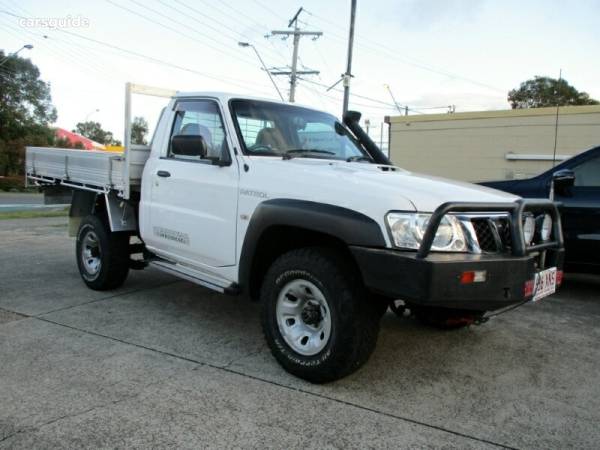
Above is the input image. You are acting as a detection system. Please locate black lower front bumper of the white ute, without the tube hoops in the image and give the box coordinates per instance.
[351,247,564,311]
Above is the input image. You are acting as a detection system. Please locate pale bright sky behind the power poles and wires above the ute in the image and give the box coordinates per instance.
[0,0,600,142]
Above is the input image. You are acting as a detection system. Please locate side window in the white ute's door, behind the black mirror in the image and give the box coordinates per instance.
[168,100,227,160]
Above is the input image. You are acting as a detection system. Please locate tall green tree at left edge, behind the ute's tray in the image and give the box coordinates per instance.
[0,51,56,176]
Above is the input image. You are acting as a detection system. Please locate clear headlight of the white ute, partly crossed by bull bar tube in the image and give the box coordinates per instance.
[386,212,467,252]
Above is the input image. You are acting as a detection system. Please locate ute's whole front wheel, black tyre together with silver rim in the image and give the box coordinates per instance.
[261,248,380,383]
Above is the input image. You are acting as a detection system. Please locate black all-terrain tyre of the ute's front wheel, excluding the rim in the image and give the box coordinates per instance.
[260,247,380,383]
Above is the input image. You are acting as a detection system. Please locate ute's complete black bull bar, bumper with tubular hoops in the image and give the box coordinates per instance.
[351,200,564,311]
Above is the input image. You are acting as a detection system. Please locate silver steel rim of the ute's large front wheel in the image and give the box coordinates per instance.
[276,280,331,356]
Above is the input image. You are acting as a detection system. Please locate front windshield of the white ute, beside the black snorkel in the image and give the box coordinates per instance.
[231,100,371,161]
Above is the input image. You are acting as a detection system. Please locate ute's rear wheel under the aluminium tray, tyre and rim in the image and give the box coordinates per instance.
[76,215,129,291]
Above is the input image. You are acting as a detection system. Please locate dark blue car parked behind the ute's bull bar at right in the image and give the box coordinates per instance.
[481,147,600,273]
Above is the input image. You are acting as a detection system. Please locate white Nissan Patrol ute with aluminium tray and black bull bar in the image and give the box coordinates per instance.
[26,83,564,383]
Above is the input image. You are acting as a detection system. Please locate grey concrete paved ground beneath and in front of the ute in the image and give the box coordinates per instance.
[0,218,600,449]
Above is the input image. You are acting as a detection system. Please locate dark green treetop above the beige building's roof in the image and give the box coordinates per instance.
[508,76,600,109]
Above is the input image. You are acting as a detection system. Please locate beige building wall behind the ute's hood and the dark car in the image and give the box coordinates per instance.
[387,105,600,182]
